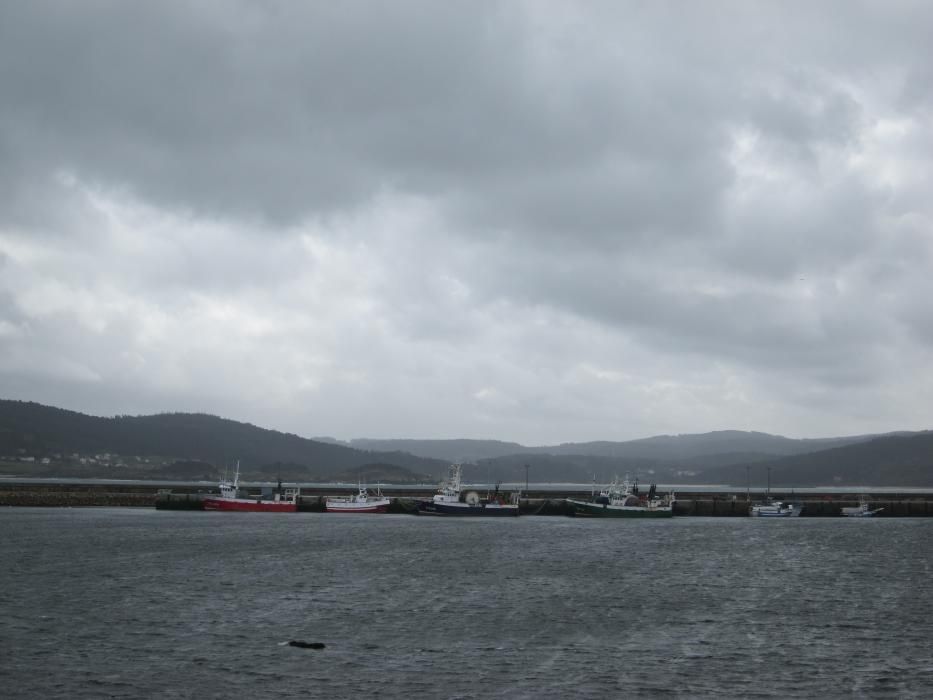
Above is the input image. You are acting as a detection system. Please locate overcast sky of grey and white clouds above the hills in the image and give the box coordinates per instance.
[0,0,933,444]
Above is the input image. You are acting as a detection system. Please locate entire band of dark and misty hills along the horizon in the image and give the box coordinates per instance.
[0,400,933,486]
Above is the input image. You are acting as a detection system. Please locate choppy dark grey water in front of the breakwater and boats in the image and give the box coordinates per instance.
[0,509,933,698]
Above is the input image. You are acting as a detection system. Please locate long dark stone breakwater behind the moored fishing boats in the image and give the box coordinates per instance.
[0,478,933,517]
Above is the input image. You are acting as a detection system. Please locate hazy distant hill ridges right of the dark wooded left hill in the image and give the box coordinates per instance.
[349,430,933,486]
